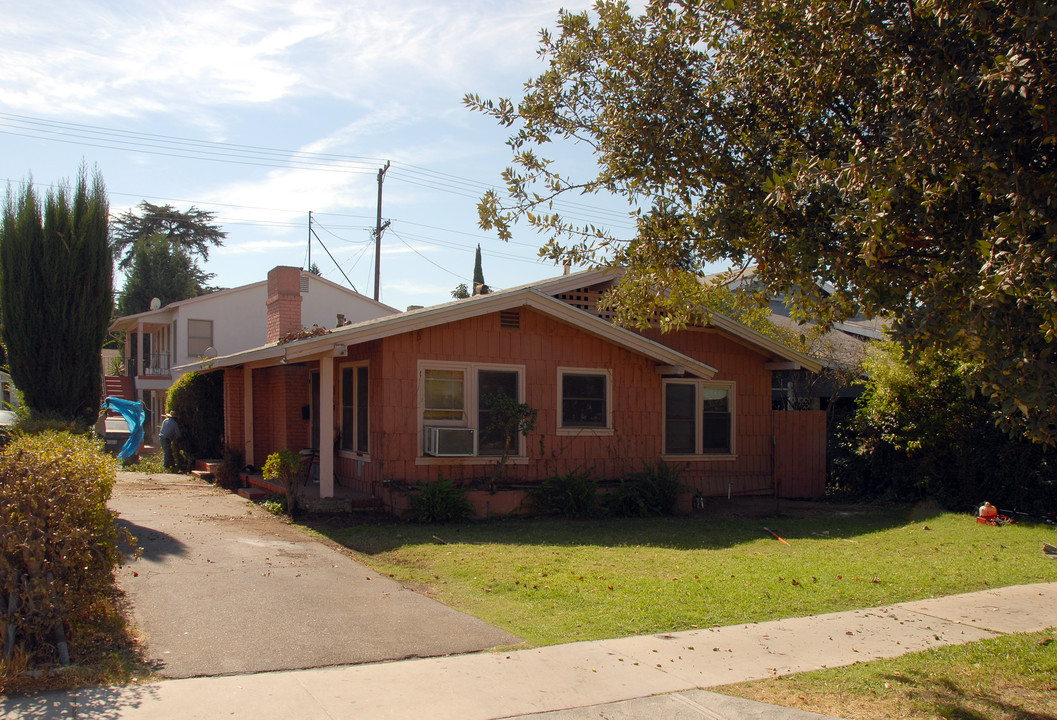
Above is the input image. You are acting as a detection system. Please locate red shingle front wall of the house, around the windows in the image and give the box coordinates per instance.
[335,309,773,495]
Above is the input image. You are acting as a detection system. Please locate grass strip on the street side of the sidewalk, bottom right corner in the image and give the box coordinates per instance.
[709,629,1057,720]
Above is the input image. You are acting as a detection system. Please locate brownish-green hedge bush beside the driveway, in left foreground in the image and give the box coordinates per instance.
[0,432,135,666]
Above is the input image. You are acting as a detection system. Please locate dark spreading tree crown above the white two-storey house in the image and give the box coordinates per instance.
[112,200,227,271]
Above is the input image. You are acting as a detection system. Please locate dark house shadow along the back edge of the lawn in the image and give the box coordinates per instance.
[301,498,944,555]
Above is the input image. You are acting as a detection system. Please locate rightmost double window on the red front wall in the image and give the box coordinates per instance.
[664,380,734,456]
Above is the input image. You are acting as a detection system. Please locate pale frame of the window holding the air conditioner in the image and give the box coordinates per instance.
[415,359,529,465]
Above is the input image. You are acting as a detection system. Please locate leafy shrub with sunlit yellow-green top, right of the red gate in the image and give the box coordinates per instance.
[831,341,1057,513]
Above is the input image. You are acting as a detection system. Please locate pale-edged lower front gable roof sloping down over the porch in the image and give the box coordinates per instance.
[175,285,716,380]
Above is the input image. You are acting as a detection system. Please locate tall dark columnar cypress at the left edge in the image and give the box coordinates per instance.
[0,168,113,422]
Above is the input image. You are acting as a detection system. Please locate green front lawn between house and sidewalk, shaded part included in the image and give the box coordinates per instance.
[314,505,1057,645]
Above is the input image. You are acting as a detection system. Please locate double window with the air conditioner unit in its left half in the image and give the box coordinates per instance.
[419,362,524,457]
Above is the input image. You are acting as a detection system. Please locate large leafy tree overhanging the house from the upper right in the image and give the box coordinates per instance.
[466,0,1057,443]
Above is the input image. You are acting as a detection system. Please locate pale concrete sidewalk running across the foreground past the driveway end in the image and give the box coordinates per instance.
[0,583,1057,720]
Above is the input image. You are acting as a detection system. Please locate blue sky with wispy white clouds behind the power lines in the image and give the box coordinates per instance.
[0,0,633,309]
